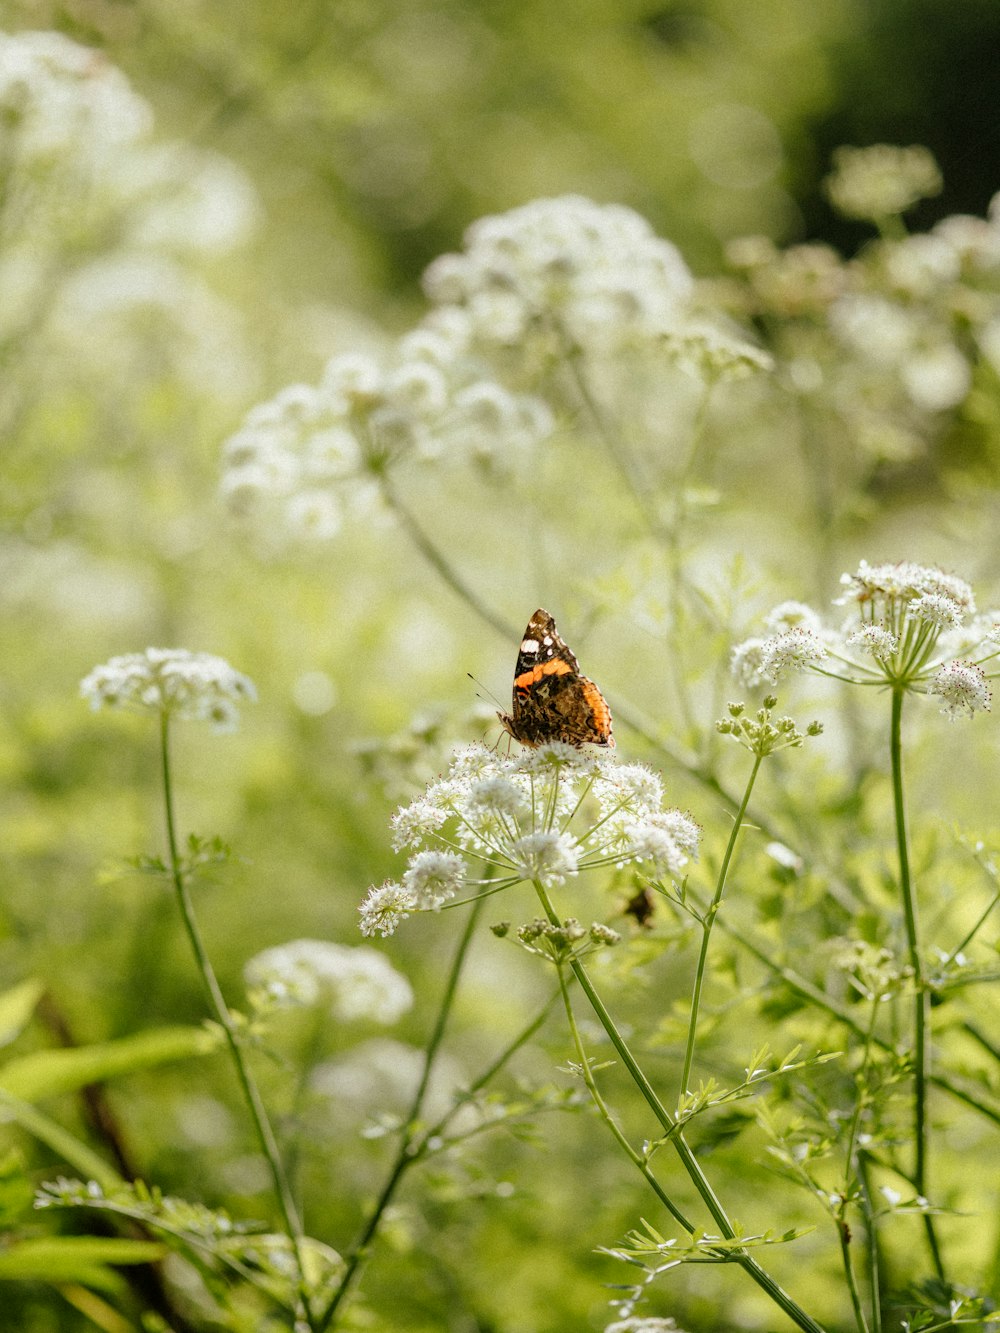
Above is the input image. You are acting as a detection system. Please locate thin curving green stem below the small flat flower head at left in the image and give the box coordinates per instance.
[160,709,317,1333]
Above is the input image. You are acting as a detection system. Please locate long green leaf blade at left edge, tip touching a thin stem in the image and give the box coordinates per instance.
[0,1028,216,1101]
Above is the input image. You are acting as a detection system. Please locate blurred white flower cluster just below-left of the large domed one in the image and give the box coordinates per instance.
[221,327,553,540]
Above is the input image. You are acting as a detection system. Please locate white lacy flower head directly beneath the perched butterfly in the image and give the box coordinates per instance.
[360,742,701,936]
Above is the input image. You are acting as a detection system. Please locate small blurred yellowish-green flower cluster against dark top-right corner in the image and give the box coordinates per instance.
[824,144,943,223]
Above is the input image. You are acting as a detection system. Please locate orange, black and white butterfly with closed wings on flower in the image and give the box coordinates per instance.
[496,608,615,746]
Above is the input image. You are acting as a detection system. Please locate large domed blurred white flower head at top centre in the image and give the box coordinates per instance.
[424,195,693,367]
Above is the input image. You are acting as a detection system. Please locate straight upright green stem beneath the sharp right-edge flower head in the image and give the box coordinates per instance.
[889,684,944,1278]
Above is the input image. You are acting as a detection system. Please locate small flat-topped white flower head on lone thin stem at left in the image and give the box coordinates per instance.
[80,648,256,732]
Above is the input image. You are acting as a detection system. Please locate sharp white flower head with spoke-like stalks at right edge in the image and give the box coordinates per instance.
[732,560,1000,717]
